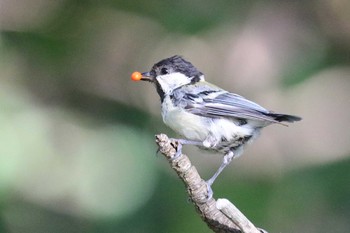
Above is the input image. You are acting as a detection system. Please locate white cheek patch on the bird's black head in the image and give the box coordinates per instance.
[156,73,191,94]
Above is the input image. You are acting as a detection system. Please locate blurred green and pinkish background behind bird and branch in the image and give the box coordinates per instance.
[0,0,350,233]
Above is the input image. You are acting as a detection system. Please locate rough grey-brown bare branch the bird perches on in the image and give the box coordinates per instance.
[156,134,266,233]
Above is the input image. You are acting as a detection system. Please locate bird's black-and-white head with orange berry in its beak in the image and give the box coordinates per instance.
[131,55,204,99]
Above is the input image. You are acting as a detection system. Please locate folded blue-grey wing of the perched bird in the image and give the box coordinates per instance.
[181,84,278,123]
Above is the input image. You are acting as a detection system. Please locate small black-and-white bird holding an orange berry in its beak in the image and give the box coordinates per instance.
[131,55,301,195]
